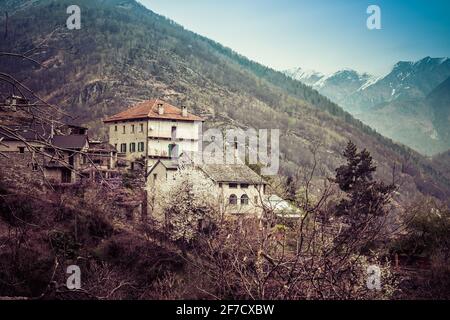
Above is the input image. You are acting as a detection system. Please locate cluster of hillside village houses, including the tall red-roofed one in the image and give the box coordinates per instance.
[0,95,300,224]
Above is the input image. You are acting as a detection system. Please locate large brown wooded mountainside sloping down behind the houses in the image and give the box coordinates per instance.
[0,0,450,205]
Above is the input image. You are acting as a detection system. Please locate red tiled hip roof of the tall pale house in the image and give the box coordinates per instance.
[103,99,204,122]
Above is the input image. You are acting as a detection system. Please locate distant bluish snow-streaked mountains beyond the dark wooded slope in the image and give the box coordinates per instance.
[286,57,450,155]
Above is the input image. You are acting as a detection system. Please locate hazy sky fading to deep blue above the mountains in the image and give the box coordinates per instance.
[140,0,450,75]
